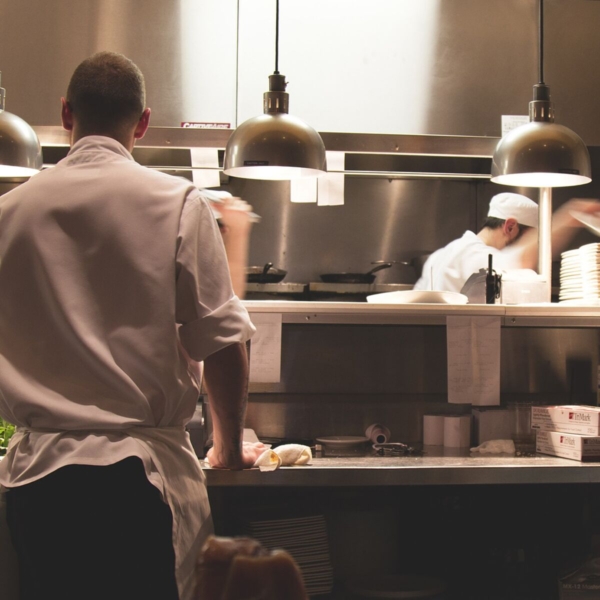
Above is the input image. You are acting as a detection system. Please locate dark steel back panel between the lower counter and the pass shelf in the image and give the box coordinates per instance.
[247,325,599,443]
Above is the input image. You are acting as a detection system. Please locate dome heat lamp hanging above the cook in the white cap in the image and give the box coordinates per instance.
[492,0,592,188]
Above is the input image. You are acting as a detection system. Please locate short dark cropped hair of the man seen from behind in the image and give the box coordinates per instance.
[66,52,146,135]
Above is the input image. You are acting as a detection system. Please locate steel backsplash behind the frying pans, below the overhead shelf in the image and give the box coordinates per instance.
[228,176,476,283]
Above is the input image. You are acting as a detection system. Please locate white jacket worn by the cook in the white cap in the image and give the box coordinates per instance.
[413,231,521,292]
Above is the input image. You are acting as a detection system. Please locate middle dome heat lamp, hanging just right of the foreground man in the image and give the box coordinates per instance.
[223,0,327,180]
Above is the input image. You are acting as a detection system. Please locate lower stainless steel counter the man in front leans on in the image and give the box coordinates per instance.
[204,455,600,487]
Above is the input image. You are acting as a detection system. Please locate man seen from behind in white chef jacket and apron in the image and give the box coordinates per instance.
[0,52,264,600]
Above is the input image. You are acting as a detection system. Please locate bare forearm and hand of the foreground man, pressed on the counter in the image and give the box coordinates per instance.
[204,344,264,469]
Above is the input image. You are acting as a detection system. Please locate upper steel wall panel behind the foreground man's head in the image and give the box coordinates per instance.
[0,0,237,127]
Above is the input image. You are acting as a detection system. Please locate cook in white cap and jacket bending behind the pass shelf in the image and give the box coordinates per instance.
[414,192,600,292]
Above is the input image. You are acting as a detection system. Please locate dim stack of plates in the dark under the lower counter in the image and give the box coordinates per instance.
[245,515,333,596]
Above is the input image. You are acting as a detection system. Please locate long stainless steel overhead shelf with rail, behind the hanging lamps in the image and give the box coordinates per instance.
[33,125,499,180]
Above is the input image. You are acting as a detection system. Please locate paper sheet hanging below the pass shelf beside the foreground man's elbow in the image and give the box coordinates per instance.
[250,313,281,383]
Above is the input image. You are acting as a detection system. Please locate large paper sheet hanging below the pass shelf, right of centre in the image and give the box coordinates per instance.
[446,316,500,406]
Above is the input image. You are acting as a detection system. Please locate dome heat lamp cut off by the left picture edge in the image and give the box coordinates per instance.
[0,73,42,179]
